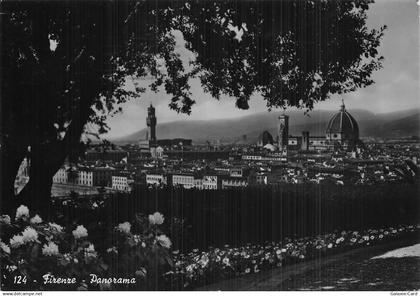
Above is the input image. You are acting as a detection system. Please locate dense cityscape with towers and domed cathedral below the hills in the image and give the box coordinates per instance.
[16,103,420,196]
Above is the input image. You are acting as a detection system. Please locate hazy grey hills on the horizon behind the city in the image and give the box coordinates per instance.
[111,109,420,144]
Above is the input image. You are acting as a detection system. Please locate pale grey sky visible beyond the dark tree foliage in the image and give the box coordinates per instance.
[105,0,420,138]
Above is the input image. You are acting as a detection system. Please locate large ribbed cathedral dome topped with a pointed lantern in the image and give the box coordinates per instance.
[326,102,359,141]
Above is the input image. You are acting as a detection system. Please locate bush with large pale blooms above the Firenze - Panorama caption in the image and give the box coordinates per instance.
[0,206,172,290]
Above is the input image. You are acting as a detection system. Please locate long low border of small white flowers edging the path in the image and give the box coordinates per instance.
[165,225,420,289]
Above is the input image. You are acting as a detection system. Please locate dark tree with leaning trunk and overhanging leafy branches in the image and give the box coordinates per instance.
[0,0,385,215]
